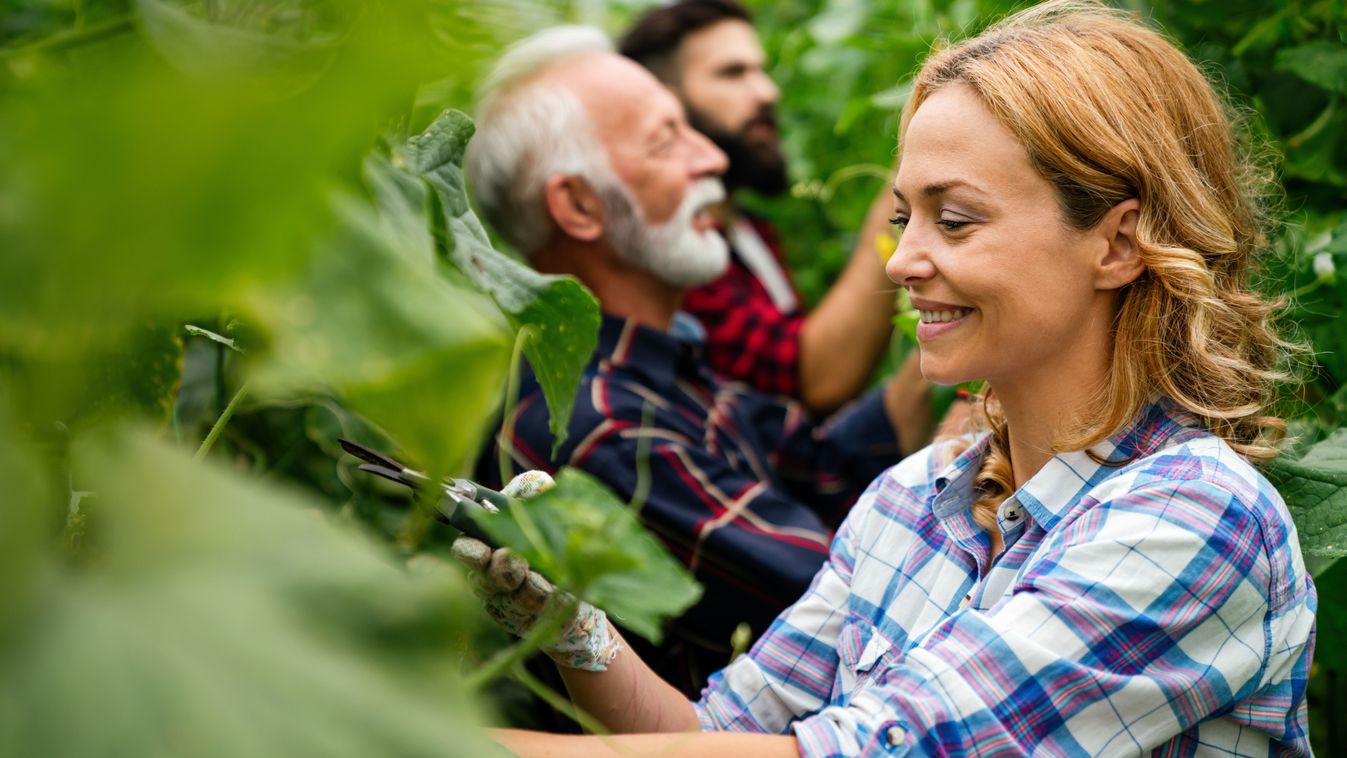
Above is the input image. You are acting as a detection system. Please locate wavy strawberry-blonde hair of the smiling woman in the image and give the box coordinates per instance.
[900,0,1299,528]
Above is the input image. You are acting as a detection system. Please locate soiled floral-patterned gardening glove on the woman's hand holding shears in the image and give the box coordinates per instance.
[453,471,621,672]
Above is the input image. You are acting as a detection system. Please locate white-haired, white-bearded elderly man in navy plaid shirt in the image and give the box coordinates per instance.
[467,27,933,692]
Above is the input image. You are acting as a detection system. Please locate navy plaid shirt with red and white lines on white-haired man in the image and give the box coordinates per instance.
[478,315,898,683]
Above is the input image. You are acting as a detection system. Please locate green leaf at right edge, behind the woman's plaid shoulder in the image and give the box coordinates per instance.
[1265,429,1347,557]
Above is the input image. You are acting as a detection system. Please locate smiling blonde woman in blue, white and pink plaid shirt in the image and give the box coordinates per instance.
[474,0,1316,755]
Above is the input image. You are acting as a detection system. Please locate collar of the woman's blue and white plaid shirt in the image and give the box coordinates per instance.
[932,397,1208,529]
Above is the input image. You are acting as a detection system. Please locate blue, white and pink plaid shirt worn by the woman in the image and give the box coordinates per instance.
[696,401,1316,755]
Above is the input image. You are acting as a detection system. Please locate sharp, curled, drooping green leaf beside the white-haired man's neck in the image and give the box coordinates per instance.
[395,110,599,454]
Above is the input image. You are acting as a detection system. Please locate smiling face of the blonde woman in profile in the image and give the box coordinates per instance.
[886,83,1114,393]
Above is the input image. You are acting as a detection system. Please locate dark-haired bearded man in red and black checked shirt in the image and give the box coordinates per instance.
[620,0,894,412]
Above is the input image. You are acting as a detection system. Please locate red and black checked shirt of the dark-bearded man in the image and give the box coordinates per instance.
[683,218,804,397]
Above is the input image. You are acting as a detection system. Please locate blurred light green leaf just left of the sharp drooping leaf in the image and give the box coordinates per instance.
[252,201,511,473]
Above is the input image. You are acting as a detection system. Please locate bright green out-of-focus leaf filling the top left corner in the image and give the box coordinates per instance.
[0,0,452,425]
